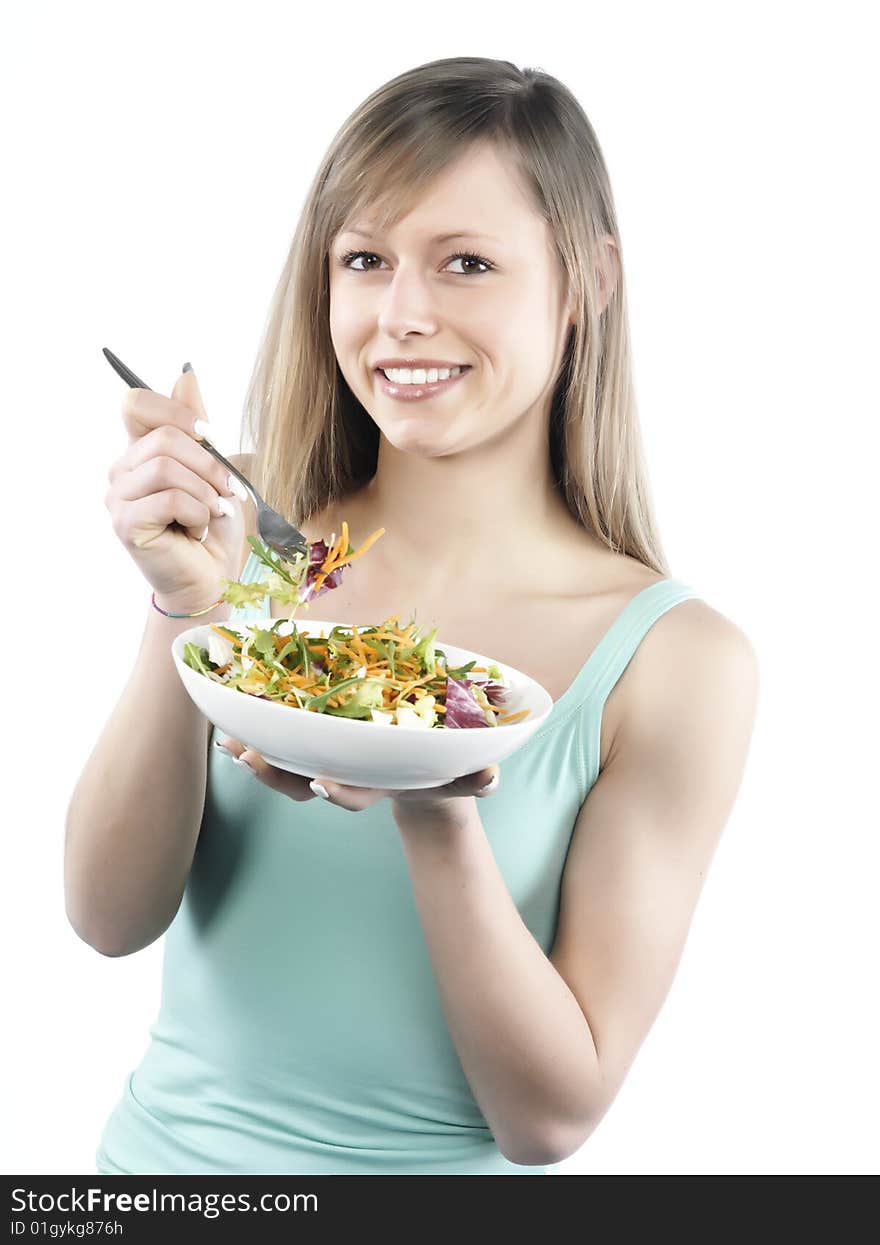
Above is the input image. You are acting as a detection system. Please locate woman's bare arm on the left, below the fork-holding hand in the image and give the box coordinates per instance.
[63,454,256,956]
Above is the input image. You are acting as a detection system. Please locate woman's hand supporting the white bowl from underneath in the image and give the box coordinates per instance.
[214,740,500,813]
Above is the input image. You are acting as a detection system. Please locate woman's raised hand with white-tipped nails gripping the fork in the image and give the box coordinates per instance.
[105,371,251,614]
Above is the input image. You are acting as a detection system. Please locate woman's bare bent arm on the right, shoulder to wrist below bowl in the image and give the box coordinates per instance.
[396,603,757,1164]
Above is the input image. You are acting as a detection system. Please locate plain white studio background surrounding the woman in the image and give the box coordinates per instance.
[0,2,880,1174]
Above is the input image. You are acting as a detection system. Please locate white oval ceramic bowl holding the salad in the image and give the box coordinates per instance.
[171,618,553,791]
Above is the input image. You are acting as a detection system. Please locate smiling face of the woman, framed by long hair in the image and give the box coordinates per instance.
[330,144,571,456]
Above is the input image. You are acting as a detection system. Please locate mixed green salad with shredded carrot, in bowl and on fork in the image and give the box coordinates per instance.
[183,523,529,730]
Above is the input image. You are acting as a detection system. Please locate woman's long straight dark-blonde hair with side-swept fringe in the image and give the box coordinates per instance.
[241,56,668,575]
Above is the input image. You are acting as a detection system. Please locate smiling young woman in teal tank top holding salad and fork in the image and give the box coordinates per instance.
[77,57,757,1175]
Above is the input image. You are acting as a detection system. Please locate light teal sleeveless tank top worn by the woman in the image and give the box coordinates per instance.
[96,554,696,1175]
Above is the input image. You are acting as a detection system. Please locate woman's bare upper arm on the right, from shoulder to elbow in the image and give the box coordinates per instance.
[550,600,761,1142]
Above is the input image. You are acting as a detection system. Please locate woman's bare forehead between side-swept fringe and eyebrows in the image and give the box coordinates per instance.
[340,144,545,244]
